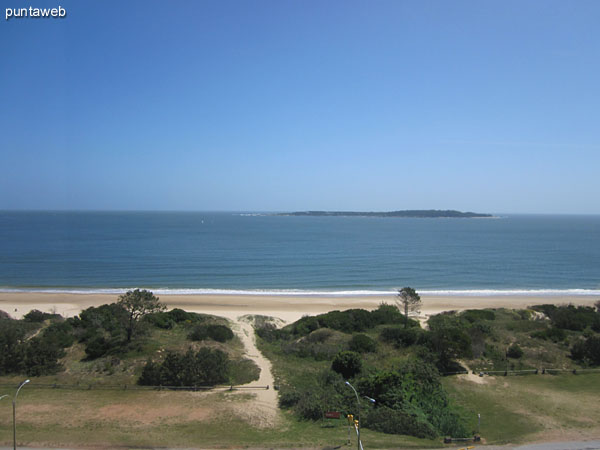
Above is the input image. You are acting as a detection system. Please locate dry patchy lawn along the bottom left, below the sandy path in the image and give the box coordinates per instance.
[0,380,441,448]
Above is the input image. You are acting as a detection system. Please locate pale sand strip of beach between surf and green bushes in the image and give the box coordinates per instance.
[0,292,599,323]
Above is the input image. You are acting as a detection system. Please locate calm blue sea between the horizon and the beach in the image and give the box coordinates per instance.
[0,212,600,295]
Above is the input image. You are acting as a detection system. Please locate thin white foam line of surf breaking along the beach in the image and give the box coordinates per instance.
[0,286,600,297]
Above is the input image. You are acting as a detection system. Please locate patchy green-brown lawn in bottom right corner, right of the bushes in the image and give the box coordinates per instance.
[444,373,600,444]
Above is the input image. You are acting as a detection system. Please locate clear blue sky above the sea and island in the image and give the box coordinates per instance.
[0,0,600,214]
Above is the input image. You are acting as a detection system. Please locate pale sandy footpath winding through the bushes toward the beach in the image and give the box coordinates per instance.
[229,317,281,427]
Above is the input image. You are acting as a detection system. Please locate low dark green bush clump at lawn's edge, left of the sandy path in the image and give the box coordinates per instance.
[138,347,229,387]
